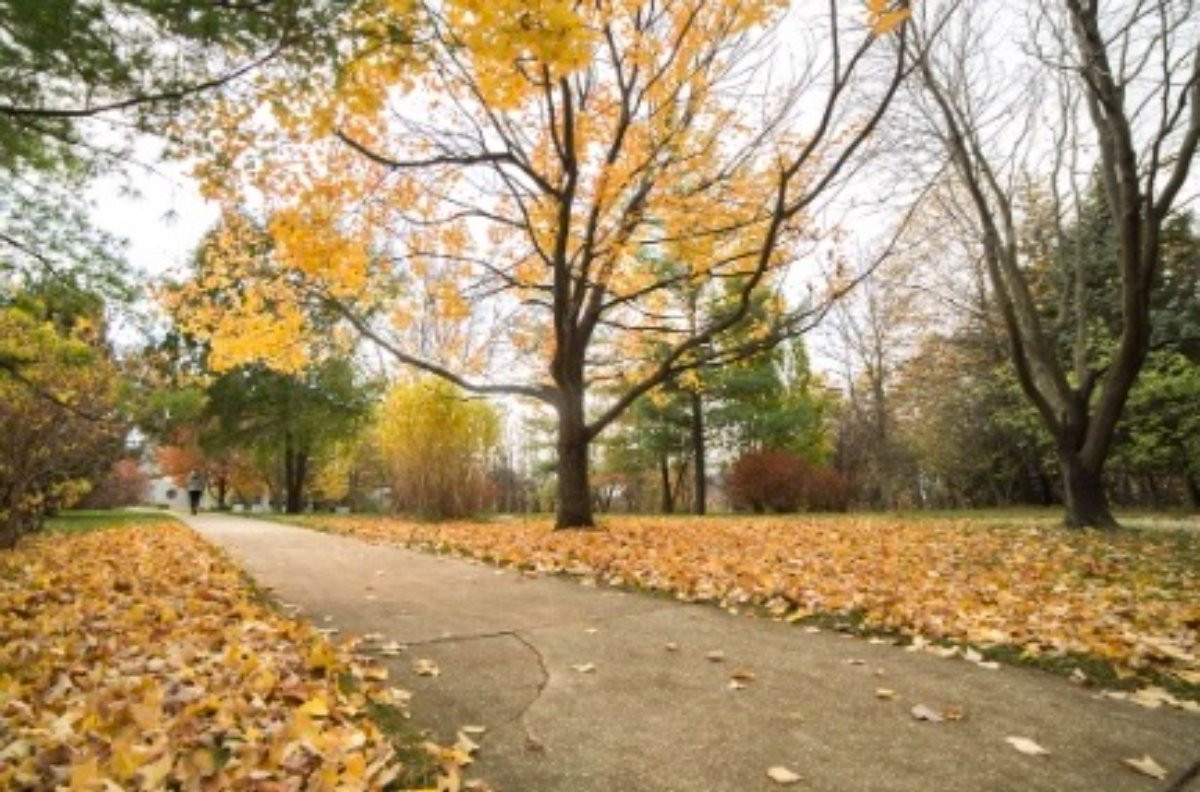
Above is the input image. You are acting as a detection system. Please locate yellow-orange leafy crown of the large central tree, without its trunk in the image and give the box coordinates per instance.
[173,0,907,380]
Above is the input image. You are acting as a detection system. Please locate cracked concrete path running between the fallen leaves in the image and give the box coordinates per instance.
[185,516,1200,792]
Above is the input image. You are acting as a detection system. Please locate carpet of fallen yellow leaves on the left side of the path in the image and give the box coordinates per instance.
[0,522,407,792]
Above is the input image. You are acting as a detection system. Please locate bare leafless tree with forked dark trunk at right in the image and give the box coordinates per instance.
[911,0,1200,527]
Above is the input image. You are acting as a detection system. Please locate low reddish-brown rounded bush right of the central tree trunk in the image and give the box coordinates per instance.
[726,450,851,514]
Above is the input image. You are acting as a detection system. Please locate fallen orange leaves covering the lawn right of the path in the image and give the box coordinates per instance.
[304,517,1200,685]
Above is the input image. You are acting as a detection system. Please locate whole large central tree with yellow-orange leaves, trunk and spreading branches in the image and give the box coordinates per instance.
[175,0,907,527]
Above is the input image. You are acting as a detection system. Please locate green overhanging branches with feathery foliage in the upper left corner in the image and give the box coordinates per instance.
[0,0,319,295]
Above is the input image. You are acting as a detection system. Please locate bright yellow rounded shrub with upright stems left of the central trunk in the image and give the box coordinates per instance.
[374,378,499,518]
